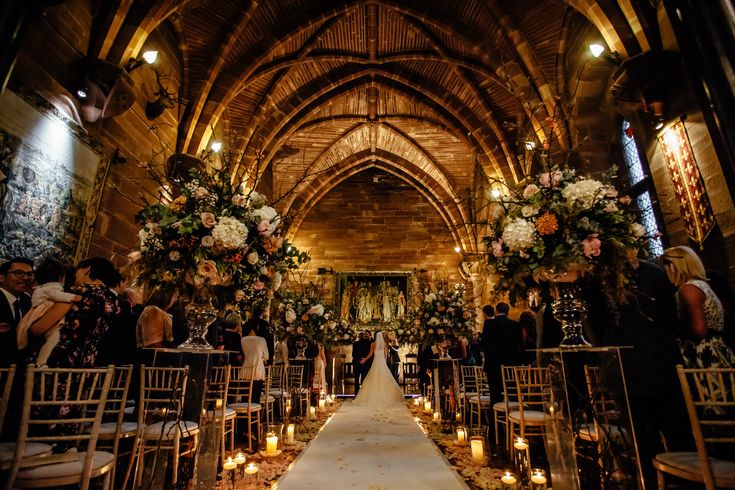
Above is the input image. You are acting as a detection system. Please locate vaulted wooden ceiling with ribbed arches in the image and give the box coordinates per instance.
[90,0,656,250]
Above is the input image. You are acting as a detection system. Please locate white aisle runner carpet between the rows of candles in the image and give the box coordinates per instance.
[278,401,467,490]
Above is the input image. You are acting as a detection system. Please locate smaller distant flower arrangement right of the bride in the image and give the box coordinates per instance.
[415,284,475,345]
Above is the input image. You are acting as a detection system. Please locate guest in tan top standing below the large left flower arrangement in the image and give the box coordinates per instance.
[135,288,178,348]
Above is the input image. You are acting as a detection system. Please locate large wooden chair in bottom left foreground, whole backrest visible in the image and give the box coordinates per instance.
[6,365,115,490]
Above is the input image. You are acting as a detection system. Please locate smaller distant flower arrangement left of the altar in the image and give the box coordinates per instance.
[271,292,333,342]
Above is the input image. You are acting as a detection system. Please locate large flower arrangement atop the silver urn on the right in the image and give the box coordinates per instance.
[483,167,647,302]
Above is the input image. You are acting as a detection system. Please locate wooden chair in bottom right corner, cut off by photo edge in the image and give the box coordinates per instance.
[653,365,735,490]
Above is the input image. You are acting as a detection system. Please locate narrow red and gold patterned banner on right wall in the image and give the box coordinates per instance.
[658,121,715,245]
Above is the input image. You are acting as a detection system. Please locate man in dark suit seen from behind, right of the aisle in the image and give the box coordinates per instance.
[480,303,523,403]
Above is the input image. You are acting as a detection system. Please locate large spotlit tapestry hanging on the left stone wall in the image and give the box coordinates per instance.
[0,129,92,264]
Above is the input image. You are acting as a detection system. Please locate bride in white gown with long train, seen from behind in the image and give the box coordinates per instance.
[354,332,405,408]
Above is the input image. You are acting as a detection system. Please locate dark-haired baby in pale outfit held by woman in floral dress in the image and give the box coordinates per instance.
[18,257,82,365]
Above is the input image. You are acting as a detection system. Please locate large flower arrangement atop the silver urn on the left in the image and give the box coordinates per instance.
[137,165,308,296]
